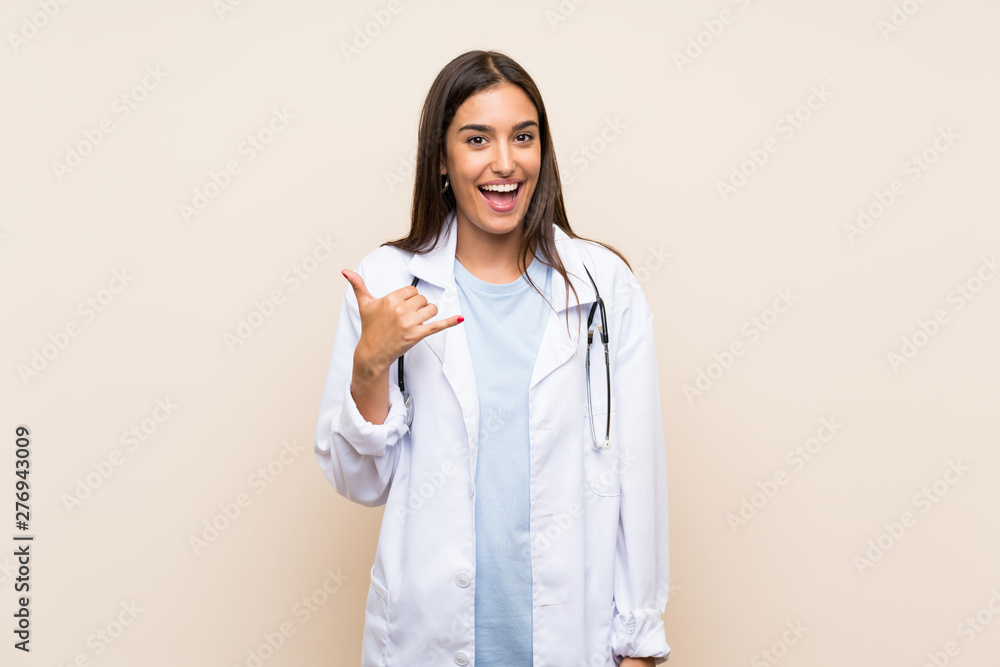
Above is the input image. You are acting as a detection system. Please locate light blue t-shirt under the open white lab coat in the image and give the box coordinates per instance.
[455,256,552,667]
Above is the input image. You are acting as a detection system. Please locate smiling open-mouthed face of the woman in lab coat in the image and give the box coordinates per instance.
[441,84,542,240]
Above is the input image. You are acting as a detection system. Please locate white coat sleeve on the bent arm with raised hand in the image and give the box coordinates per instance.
[314,263,408,507]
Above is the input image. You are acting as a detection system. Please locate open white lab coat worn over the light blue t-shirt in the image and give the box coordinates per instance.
[315,213,670,667]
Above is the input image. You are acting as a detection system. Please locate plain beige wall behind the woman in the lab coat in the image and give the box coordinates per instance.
[0,0,1000,667]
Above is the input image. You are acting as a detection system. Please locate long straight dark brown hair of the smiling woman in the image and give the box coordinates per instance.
[382,51,632,326]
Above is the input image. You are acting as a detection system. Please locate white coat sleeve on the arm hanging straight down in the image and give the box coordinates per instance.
[612,302,670,665]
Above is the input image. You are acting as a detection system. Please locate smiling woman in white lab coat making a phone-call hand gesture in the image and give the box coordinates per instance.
[315,51,670,667]
